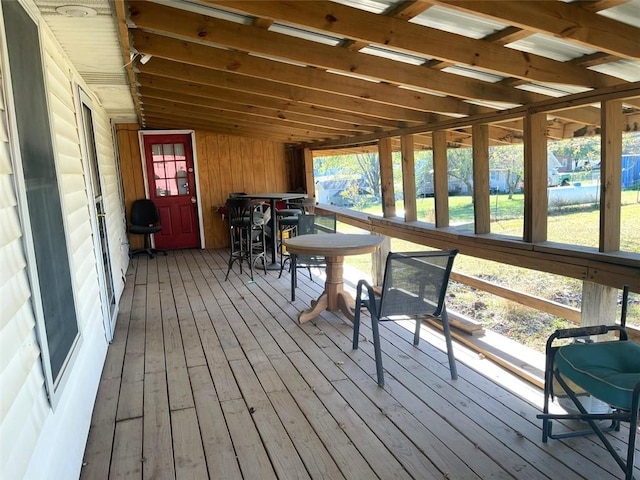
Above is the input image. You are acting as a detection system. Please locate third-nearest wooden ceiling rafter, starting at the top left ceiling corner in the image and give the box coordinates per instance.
[130,2,546,104]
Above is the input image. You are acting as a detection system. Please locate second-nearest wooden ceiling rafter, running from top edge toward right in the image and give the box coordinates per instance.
[206,0,622,88]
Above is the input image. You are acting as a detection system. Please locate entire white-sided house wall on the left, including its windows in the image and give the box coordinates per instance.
[0,1,128,480]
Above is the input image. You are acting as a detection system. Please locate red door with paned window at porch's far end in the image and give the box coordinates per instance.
[143,134,200,250]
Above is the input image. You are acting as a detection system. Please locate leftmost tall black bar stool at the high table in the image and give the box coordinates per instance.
[225,197,268,281]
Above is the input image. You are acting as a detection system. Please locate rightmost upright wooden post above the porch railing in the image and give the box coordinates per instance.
[599,100,624,252]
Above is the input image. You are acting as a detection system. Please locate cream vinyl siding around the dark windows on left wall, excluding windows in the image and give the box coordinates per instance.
[0,5,128,480]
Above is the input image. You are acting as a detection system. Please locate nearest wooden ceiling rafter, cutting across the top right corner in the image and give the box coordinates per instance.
[437,0,640,59]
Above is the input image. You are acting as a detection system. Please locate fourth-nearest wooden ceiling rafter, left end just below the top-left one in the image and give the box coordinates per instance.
[131,30,492,115]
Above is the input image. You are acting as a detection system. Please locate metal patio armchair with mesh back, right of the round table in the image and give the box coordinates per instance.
[353,250,458,387]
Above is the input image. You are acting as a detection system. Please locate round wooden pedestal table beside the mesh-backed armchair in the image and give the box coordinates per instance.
[284,233,382,323]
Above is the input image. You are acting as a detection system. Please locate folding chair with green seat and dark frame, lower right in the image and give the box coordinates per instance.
[537,286,640,480]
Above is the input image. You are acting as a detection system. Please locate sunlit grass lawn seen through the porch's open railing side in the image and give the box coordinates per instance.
[338,192,640,351]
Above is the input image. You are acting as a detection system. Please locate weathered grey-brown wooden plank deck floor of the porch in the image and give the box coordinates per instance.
[82,250,638,480]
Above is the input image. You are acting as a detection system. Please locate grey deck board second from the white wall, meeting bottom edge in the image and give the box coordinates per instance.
[110,418,145,480]
